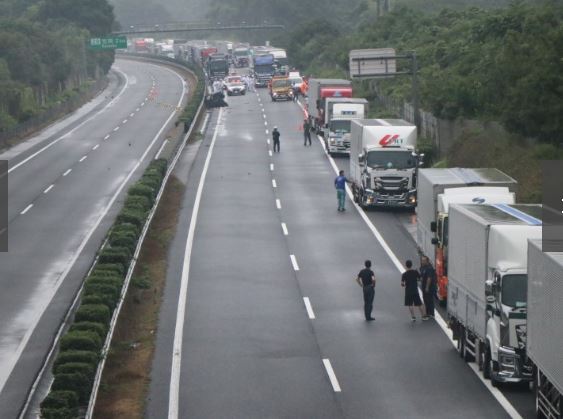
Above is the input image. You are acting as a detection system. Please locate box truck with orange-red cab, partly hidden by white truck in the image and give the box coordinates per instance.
[416,167,518,304]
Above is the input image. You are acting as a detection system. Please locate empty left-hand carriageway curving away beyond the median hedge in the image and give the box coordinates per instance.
[0,60,187,418]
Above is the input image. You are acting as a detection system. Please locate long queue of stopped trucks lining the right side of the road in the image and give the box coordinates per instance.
[174,38,563,419]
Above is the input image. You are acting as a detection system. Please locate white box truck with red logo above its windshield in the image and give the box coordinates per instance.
[350,119,423,208]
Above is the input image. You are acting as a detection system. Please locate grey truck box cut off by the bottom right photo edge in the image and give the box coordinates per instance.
[526,240,563,419]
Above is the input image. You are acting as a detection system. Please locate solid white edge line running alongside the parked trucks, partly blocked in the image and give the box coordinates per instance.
[298,99,522,419]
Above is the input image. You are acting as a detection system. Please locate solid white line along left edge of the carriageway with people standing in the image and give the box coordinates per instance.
[168,108,223,419]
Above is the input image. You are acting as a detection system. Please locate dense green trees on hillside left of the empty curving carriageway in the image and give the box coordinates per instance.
[0,0,114,131]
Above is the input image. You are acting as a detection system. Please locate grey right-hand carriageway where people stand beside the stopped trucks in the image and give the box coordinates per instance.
[146,78,528,418]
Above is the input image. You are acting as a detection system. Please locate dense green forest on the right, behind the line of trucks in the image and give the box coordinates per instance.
[277,1,563,143]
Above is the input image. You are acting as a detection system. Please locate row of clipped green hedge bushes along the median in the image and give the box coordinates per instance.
[41,159,173,419]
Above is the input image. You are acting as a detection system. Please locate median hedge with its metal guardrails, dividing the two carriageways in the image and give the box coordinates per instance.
[28,55,204,419]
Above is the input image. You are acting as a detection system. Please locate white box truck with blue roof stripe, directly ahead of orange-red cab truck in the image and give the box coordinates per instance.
[447,204,542,386]
